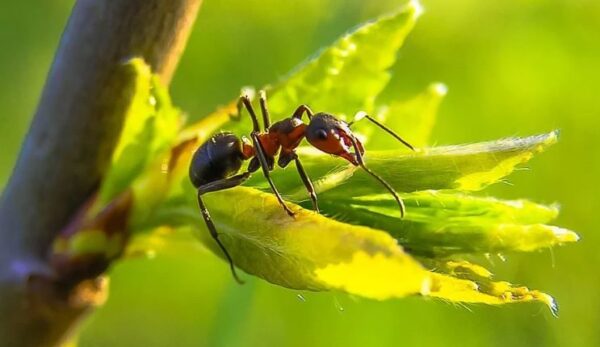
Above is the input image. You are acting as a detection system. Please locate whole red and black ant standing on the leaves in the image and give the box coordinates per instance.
[189,91,414,284]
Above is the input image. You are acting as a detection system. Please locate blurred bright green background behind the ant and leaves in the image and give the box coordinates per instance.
[0,0,600,346]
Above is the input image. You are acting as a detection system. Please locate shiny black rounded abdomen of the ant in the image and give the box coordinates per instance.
[189,132,244,188]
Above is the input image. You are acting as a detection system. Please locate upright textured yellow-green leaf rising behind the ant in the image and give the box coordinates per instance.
[269,2,422,116]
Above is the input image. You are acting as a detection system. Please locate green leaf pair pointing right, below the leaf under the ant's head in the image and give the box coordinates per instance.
[321,191,579,257]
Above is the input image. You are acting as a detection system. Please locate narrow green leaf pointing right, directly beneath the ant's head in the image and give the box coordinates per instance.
[247,131,558,201]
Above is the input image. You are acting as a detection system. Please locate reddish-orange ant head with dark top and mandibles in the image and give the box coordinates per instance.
[306,113,365,165]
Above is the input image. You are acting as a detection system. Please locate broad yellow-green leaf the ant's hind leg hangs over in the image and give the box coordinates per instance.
[152,187,425,296]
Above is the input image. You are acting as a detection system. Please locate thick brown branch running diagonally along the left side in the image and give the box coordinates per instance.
[0,0,201,346]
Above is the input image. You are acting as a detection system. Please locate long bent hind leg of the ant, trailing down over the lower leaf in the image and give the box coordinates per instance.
[198,172,250,284]
